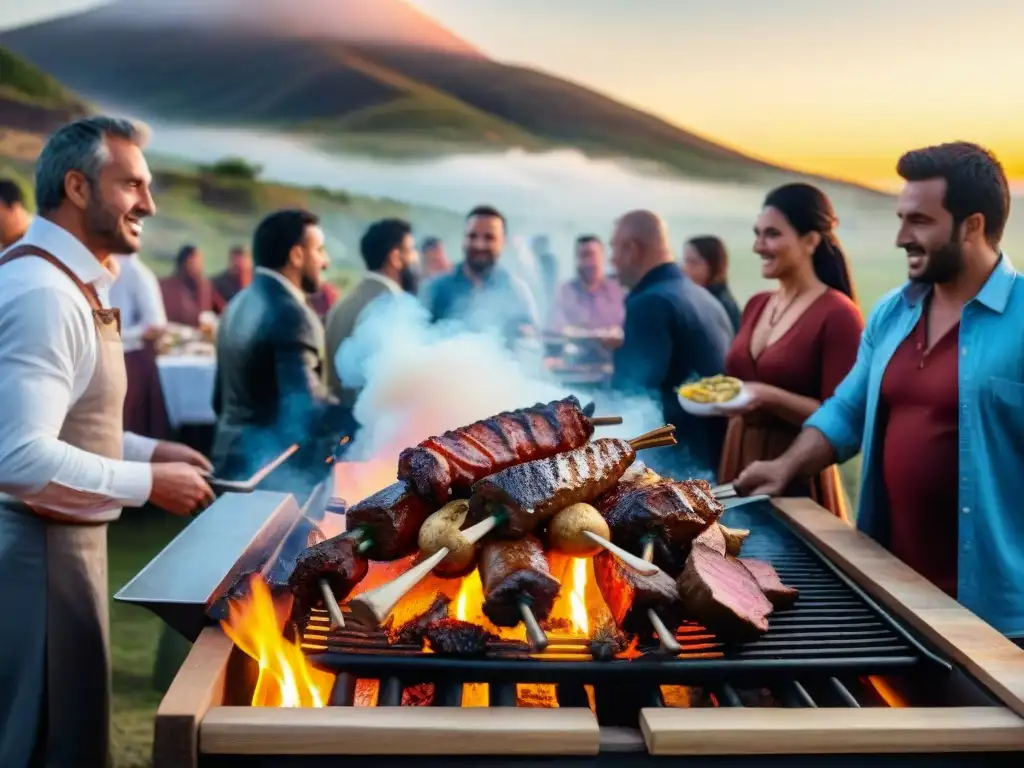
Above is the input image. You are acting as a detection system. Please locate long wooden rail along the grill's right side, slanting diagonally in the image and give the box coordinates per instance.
[772,499,1024,717]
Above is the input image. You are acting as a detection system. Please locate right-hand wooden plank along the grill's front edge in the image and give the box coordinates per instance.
[640,707,1024,756]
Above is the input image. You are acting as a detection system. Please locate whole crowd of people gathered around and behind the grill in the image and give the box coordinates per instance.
[0,117,1024,766]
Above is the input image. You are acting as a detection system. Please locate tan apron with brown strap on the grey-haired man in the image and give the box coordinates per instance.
[0,246,127,768]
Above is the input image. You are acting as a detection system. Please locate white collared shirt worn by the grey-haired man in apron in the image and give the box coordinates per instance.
[0,216,157,517]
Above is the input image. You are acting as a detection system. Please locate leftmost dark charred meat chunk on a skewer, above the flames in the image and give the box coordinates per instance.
[288,534,370,625]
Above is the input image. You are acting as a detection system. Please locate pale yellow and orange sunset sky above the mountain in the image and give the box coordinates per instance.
[0,0,1024,185]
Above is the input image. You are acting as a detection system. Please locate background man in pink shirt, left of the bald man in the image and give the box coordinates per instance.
[550,234,626,333]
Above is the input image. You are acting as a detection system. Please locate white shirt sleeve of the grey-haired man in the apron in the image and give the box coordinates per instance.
[0,289,153,515]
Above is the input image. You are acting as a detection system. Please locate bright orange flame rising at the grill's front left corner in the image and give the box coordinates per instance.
[220,574,334,708]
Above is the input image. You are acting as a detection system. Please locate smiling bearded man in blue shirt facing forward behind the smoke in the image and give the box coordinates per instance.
[428,206,540,340]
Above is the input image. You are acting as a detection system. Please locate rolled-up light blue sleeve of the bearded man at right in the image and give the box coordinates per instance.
[804,311,877,462]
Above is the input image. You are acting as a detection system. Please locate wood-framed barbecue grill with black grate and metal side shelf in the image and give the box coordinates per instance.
[117,493,1024,768]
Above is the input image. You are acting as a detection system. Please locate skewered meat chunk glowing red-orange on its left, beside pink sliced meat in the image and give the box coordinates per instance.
[594,552,685,636]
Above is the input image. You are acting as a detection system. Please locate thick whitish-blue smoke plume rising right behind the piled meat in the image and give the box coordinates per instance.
[337,296,663,464]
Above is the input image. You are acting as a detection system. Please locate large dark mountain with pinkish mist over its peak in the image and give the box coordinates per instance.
[0,0,864,188]
